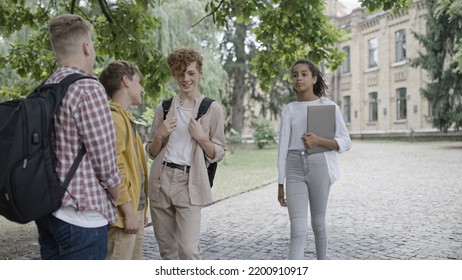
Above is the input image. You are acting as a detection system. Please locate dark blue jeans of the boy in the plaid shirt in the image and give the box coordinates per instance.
[35,214,107,260]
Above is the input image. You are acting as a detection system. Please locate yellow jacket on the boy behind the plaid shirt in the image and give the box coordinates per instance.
[109,102,148,228]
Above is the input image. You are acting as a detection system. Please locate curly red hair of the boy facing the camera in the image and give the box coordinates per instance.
[167,48,203,77]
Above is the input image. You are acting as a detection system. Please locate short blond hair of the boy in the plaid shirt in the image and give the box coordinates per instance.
[48,14,91,57]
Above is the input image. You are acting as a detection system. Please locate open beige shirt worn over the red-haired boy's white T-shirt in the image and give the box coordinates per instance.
[146,95,226,206]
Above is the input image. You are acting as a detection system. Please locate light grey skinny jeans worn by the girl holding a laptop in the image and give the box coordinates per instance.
[286,151,331,260]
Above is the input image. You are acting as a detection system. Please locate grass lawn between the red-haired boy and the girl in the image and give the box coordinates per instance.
[212,144,277,201]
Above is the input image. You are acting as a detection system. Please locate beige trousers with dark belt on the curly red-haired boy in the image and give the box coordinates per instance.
[149,166,202,260]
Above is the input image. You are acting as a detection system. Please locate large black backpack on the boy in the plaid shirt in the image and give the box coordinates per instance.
[0,73,94,224]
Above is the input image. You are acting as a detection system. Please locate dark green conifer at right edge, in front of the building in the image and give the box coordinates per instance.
[413,0,462,132]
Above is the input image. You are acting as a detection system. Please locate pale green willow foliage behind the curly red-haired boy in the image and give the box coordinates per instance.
[152,0,228,101]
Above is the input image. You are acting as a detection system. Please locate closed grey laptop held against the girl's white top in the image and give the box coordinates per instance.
[307,105,335,154]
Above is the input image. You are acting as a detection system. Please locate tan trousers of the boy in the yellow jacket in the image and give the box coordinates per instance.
[106,210,144,260]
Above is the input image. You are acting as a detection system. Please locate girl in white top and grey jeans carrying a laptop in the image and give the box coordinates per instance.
[278,59,352,259]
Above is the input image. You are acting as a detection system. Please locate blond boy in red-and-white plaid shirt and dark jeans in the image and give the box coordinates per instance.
[35,14,121,259]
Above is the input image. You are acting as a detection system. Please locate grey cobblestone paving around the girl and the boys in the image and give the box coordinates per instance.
[143,141,462,260]
